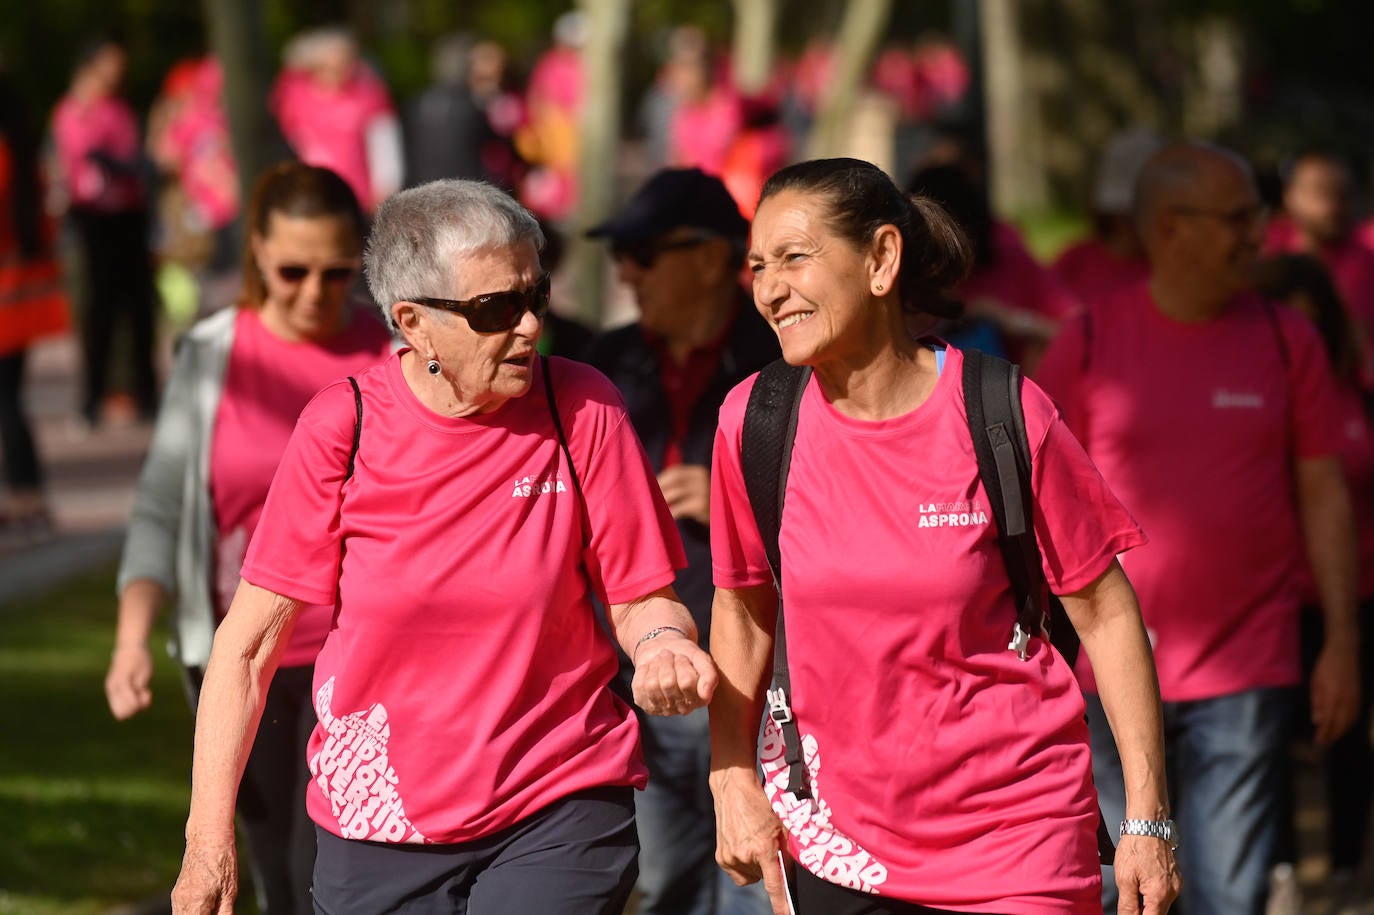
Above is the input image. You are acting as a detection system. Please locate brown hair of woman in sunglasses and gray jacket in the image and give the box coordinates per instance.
[240,162,367,308]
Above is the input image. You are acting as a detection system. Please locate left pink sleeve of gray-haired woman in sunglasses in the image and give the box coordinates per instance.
[240,382,357,605]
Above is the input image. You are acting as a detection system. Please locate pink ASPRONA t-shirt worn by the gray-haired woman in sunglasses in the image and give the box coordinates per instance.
[243,356,683,844]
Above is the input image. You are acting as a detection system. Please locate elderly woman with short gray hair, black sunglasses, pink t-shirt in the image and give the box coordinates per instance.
[173,180,717,915]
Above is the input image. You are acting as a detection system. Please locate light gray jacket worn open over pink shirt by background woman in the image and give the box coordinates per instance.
[115,308,238,668]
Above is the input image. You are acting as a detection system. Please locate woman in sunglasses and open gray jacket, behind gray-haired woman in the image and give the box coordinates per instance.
[104,162,390,915]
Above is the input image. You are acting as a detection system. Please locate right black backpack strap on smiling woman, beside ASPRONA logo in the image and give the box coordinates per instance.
[963,349,1116,864]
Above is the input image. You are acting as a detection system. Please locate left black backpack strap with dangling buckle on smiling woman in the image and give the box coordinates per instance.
[739,359,811,800]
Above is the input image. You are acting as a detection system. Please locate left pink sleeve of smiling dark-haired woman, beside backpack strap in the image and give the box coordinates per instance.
[710,375,772,588]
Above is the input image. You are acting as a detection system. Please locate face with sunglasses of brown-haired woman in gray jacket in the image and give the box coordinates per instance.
[253,213,360,342]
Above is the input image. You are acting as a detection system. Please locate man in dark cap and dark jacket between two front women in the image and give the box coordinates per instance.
[585,169,779,915]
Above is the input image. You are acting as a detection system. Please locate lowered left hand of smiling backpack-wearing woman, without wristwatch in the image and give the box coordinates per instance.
[710,769,791,915]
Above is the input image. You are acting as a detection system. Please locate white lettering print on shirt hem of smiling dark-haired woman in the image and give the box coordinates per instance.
[758,719,888,894]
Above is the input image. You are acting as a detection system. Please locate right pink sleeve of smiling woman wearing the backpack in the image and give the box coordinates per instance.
[1022,376,1146,594]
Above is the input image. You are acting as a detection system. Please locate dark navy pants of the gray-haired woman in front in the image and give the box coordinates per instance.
[315,787,639,915]
